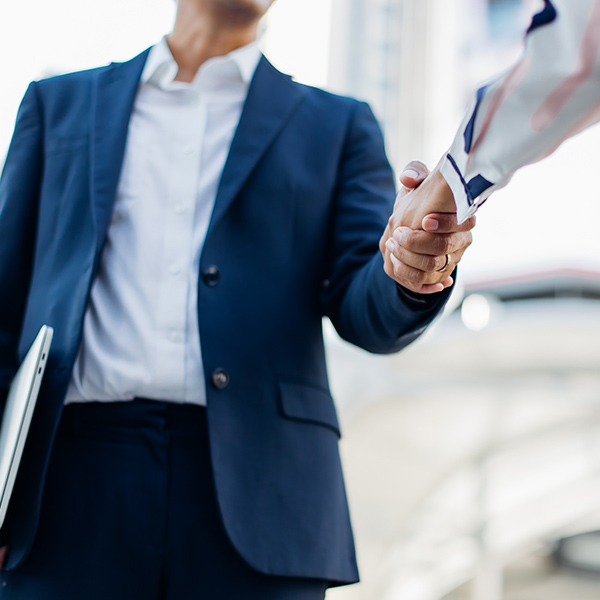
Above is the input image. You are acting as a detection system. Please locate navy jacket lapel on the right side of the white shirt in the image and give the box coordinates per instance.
[209,56,304,233]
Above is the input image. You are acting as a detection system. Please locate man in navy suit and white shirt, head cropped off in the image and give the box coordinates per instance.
[0,0,473,600]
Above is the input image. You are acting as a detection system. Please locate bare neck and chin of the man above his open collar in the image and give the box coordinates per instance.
[167,0,262,83]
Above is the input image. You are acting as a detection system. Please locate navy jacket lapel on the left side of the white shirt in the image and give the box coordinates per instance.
[91,50,149,253]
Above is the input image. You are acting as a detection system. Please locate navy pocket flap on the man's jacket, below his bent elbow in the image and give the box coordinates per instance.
[279,382,340,436]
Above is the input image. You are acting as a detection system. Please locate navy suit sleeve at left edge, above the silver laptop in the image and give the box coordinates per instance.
[0,84,43,403]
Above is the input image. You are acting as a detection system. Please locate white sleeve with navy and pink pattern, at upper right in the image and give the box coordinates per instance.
[441,0,600,222]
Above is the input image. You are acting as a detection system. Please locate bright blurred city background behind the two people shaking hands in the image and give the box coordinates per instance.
[0,0,600,600]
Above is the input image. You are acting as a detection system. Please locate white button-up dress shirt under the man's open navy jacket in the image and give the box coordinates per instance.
[66,39,261,404]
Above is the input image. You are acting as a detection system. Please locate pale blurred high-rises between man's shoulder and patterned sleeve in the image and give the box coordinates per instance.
[329,0,534,167]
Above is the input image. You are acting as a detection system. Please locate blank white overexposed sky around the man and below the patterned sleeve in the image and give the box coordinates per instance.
[0,0,600,280]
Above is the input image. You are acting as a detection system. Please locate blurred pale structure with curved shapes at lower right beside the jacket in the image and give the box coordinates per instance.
[328,270,600,600]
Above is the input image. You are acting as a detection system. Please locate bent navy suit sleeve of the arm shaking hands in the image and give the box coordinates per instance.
[323,103,450,353]
